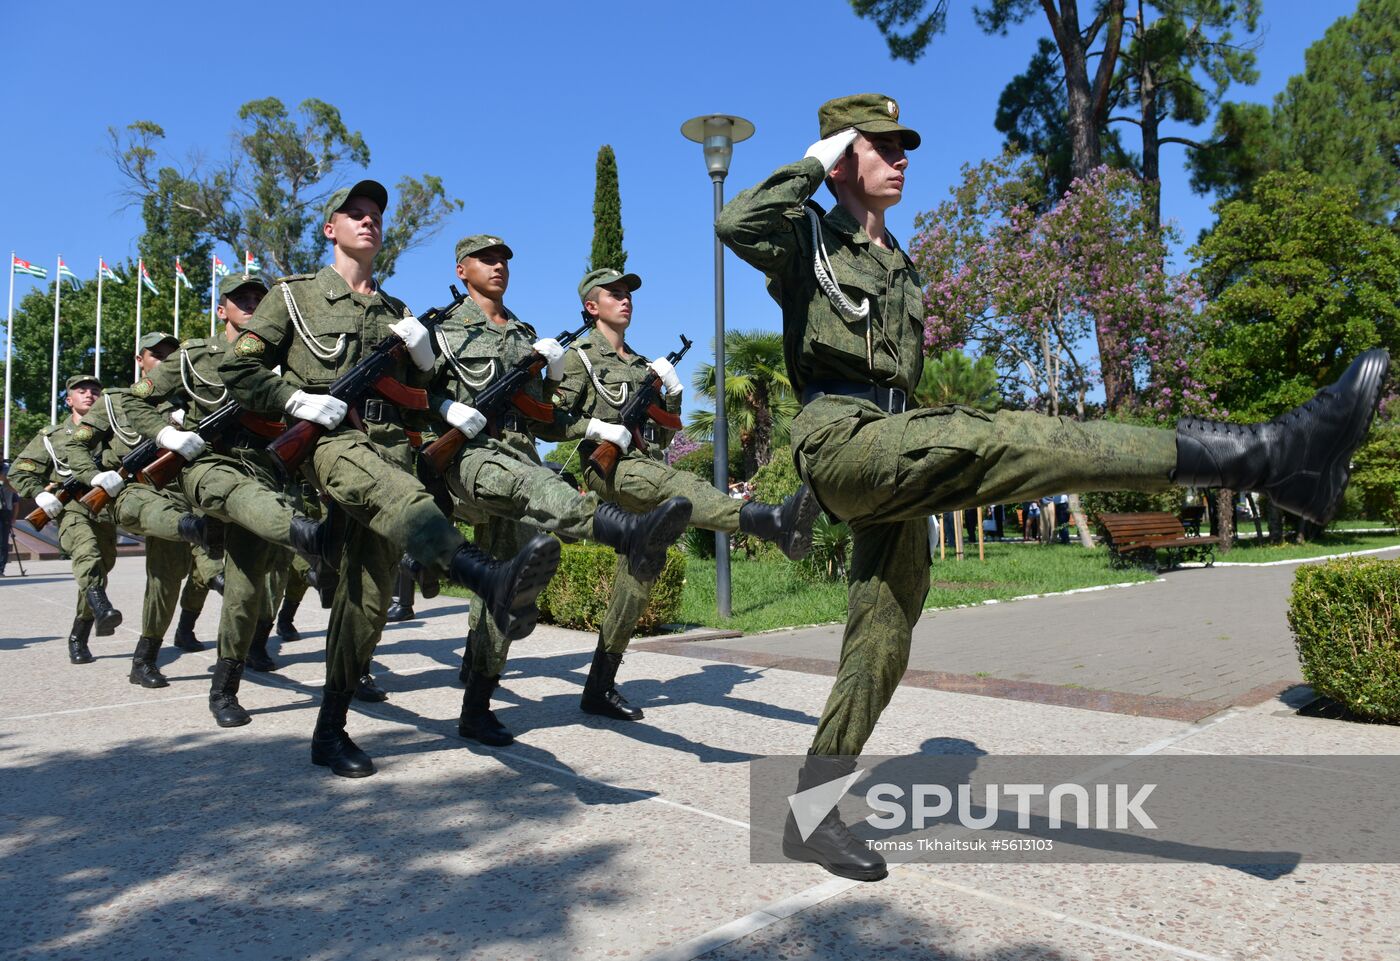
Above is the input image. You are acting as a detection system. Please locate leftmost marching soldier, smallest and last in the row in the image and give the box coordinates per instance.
[10,374,122,664]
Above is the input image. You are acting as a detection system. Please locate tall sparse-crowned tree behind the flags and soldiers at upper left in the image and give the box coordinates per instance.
[108,97,462,279]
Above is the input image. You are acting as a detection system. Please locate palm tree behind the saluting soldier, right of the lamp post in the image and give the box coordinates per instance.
[686,331,801,478]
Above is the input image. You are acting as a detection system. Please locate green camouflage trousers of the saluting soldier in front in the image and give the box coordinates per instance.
[792,398,1176,755]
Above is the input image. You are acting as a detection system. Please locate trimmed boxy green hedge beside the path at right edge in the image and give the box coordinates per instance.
[1288,559,1400,721]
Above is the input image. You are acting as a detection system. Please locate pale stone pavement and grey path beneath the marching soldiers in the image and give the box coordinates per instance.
[0,549,1400,961]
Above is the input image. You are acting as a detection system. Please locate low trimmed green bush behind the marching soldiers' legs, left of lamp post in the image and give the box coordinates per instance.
[539,544,686,635]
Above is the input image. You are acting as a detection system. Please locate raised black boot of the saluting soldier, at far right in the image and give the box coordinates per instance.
[1172,350,1390,525]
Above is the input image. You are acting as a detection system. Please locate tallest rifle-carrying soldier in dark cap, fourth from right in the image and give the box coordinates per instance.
[220,181,559,777]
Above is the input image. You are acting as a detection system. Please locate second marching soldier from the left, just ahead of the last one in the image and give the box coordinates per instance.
[69,331,223,688]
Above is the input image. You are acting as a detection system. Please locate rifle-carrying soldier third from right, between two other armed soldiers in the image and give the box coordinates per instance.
[425,234,690,745]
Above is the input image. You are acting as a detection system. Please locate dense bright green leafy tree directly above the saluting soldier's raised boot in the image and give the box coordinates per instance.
[1193,172,1400,422]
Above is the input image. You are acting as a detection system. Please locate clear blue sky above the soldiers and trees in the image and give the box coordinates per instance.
[0,0,1354,406]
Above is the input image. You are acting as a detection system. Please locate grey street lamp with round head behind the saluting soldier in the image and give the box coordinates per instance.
[680,113,753,618]
